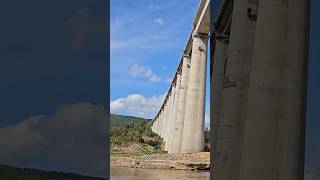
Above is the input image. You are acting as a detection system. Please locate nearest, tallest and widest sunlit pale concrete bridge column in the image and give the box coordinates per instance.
[181,34,208,153]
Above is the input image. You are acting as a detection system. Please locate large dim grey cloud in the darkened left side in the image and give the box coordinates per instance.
[0,103,107,176]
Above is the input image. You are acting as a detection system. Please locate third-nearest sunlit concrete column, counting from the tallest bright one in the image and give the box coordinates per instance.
[168,72,181,153]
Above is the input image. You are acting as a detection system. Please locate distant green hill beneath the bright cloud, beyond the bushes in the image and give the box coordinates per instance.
[110,114,151,127]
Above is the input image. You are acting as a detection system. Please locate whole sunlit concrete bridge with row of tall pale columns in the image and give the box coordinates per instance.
[152,0,210,153]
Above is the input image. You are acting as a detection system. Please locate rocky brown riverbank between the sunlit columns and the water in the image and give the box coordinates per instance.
[110,152,210,170]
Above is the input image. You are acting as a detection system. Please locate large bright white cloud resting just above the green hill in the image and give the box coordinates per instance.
[110,94,165,118]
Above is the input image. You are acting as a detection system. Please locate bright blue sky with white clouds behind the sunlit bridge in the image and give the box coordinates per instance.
[110,0,209,127]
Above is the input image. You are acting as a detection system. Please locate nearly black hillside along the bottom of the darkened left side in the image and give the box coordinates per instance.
[0,165,104,180]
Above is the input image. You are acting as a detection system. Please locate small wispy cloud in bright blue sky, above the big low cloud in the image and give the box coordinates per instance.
[130,64,161,82]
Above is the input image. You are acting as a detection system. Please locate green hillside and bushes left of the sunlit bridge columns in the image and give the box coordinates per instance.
[110,115,166,156]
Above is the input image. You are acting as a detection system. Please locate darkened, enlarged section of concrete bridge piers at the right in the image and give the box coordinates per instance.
[211,0,310,180]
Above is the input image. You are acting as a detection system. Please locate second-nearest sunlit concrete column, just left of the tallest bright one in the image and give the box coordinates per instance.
[171,55,190,153]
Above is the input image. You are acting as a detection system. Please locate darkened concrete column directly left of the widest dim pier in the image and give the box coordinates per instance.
[213,0,258,180]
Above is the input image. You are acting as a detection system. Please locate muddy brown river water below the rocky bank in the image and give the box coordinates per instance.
[110,167,210,180]
